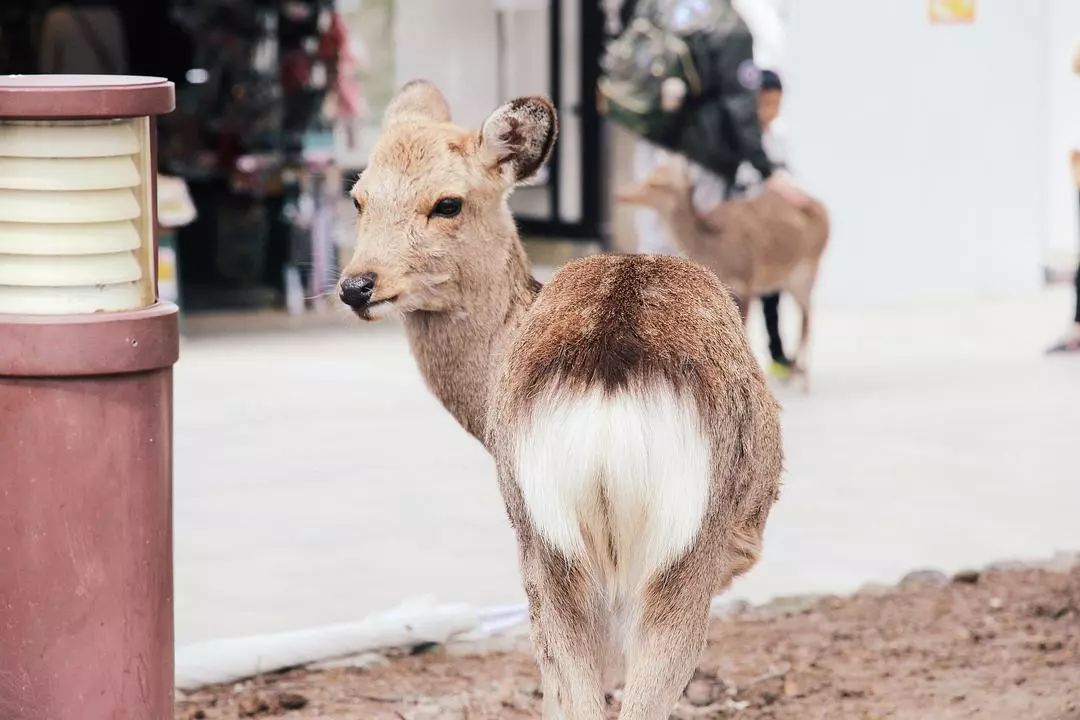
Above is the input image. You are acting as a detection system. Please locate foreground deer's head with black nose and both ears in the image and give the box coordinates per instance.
[340,81,556,320]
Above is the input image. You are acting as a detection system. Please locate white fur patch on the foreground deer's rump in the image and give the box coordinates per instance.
[514,383,712,596]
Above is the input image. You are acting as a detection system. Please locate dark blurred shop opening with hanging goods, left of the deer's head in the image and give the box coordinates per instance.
[0,0,357,311]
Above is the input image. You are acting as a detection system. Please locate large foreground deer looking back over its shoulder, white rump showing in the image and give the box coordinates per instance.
[339,81,783,720]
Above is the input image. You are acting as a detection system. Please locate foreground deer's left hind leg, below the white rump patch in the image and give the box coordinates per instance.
[522,538,608,720]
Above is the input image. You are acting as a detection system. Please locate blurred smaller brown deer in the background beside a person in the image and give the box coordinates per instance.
[618,160,829,390]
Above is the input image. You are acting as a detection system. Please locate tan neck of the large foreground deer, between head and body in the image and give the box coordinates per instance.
[405,225,540,444]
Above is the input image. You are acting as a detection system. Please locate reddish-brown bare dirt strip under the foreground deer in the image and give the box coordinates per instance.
[176,567,1080,720]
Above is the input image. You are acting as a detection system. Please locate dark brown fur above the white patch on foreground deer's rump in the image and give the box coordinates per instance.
[501,255,751,398]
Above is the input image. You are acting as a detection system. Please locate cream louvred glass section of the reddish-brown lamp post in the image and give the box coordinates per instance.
[0,118,156,315]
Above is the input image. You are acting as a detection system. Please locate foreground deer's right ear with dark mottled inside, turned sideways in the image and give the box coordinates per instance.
[480,96,558,182]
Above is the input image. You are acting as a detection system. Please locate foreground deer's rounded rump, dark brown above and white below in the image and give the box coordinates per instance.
[490,256,780,607]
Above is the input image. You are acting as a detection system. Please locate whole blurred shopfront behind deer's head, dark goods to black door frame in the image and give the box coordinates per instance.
[0,0,603,313]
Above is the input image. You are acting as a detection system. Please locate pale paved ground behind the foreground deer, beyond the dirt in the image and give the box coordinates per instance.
[175,290,1080,644]
